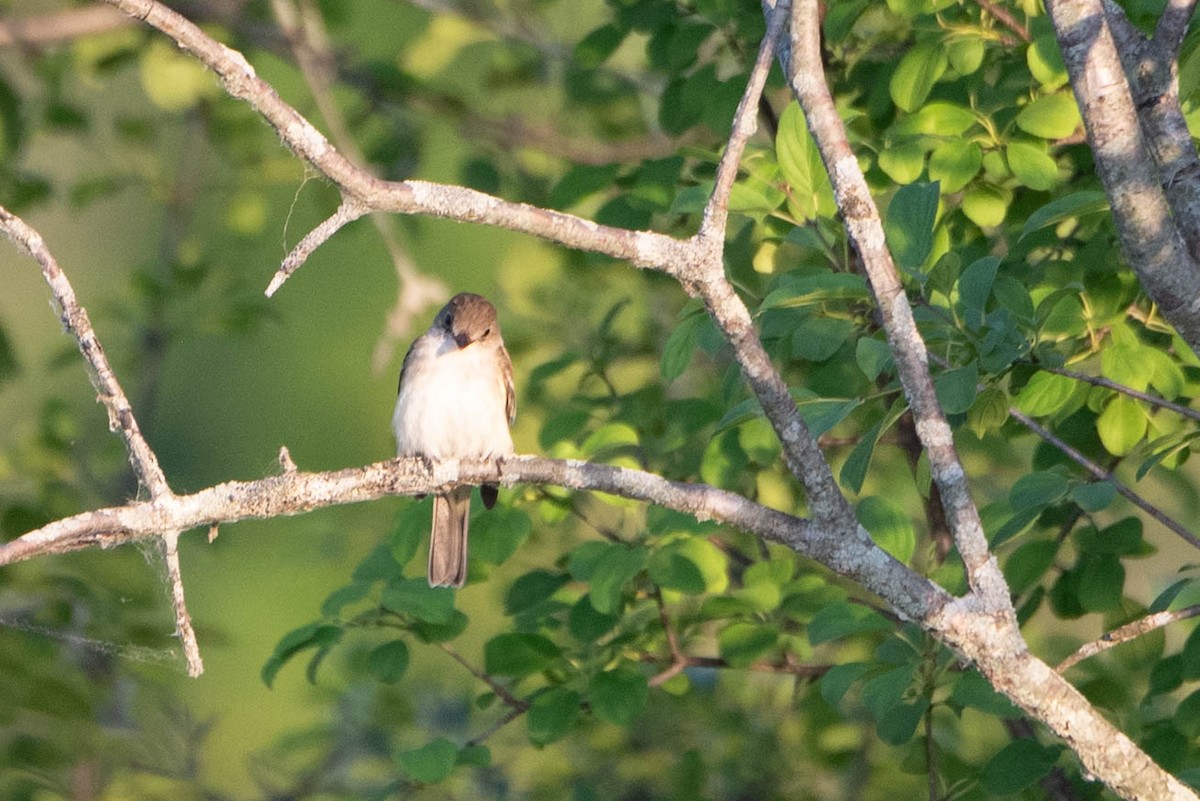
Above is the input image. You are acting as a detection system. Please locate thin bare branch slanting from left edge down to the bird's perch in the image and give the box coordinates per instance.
[0,207,170,498]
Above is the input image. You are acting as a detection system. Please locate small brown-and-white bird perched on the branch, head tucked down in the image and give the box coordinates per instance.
[391,293,516,588]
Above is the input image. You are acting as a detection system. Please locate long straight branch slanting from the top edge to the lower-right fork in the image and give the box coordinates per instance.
[780,0,1013,615]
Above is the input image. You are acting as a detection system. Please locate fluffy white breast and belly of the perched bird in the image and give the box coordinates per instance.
[391,335,512,459]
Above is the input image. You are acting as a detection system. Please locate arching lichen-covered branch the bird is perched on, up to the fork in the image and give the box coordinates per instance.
[0,456,949,620]
